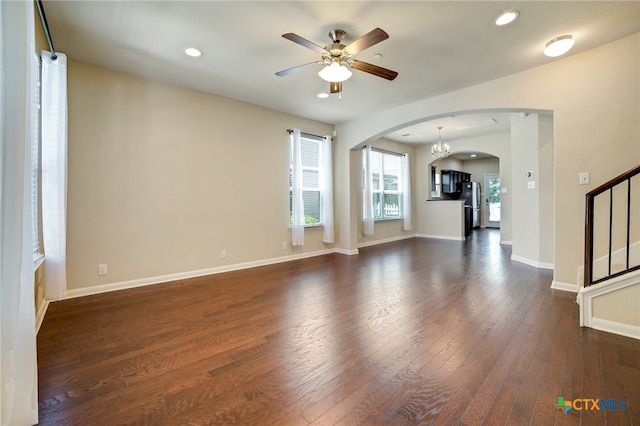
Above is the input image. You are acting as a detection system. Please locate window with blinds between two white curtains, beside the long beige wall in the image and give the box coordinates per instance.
[289,136,324,226]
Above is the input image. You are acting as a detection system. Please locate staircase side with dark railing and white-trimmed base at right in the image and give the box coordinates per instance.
[578,165,640,339]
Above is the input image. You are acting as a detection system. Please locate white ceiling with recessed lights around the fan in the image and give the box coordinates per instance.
[44,0,640,143]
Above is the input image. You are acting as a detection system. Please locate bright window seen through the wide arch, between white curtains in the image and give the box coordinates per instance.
[371,149,402,220]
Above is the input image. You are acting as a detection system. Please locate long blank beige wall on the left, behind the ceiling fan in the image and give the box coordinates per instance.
[67,61,333,289]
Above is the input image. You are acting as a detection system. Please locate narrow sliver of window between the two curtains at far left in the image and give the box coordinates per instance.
[31,54,42,261]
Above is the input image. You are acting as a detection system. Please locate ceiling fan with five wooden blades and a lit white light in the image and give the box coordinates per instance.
[276,28,398,93]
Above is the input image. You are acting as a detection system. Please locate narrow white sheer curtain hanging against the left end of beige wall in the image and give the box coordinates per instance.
[42,52,67,300]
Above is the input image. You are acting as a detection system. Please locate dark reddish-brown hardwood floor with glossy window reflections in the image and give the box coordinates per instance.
[38,230,640,426]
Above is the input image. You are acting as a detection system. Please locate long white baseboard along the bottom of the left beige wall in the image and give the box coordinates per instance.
[64,249,335,300]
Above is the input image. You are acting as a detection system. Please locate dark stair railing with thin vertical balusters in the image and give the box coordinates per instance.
[584,165,640,287]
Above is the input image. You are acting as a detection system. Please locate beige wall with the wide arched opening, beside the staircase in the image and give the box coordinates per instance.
[336,34,640,285]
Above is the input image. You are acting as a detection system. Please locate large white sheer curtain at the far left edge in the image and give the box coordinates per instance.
[0,1,38,425]
